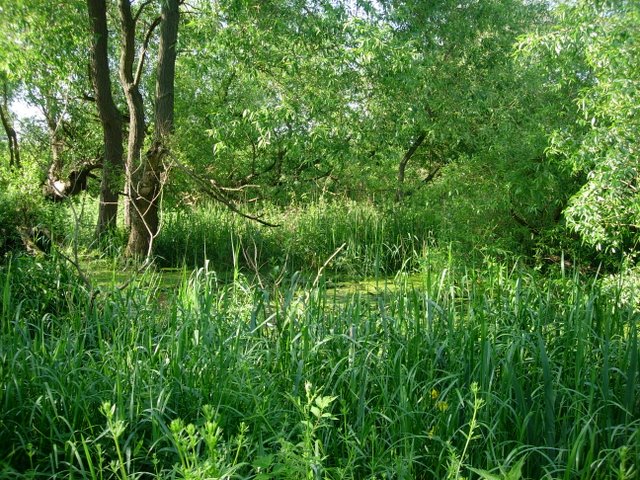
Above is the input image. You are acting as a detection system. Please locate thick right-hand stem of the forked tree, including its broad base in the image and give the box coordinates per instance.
[127,0,179,257]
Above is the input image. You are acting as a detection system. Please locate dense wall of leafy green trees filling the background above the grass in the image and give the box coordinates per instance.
[0,0,639,261]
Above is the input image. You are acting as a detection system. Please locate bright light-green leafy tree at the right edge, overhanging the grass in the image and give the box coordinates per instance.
[521,0,640,256]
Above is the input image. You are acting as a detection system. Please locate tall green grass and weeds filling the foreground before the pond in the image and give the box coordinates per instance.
[0,253,640,479]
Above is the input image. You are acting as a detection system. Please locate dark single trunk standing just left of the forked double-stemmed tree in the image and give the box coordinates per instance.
[87,0,123,237]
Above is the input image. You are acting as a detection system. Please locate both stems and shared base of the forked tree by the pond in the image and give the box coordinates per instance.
[112,0,182,257]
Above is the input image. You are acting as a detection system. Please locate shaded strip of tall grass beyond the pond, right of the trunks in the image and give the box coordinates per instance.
[155,201,434,276]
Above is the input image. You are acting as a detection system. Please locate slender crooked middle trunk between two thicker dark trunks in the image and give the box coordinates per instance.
[118,0,150,256]
